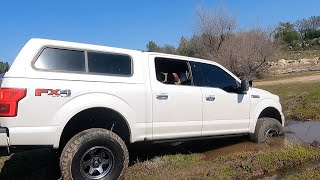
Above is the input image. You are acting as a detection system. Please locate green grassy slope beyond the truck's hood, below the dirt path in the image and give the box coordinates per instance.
[258,82,320,120]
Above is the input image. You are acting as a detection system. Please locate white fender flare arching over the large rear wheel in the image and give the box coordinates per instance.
[53,93,136,148]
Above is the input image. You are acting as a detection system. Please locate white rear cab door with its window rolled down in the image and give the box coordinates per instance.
[149,55,202,139]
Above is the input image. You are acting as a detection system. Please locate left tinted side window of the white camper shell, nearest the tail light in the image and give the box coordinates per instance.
[34,48,85,72]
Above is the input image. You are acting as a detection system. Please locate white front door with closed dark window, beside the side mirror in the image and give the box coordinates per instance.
[191,62,250,136]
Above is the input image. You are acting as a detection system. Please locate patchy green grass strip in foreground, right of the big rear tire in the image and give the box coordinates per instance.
[126,146,320,180]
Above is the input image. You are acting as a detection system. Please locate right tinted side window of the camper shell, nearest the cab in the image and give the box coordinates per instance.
[88,52,132,75]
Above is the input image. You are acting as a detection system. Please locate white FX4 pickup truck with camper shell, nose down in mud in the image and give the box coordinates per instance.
[0,39,284,179]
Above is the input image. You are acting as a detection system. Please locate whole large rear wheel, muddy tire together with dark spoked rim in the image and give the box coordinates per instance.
[60,128,129,180]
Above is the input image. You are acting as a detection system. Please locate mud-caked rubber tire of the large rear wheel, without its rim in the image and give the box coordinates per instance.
[60,128,129,180]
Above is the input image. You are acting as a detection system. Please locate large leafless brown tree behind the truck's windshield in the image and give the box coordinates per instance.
[197,6,278,79]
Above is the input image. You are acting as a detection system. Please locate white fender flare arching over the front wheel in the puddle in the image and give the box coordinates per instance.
[249,98,284,133]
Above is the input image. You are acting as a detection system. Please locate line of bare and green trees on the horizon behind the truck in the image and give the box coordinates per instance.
[146,6,320,79]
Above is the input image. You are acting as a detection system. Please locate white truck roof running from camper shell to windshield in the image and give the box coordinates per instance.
[4,38,239,85]
